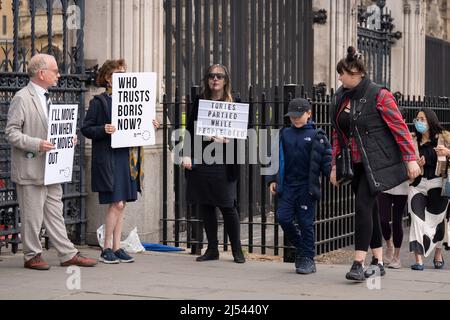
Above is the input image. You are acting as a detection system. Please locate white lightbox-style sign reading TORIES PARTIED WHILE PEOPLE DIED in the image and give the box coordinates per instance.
[196,100,249,139]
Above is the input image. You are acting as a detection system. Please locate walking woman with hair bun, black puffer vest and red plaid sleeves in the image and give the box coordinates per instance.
[330,47,420,281]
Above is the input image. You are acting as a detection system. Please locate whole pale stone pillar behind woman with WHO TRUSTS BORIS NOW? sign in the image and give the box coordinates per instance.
[81,0,173,244]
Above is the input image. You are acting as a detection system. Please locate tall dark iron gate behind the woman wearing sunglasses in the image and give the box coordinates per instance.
[163,0,314,245]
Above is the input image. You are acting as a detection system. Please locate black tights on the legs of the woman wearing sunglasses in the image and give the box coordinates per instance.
[199,205,241,250]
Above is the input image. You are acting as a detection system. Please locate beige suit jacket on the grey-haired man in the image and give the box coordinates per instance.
[5,83,48,185]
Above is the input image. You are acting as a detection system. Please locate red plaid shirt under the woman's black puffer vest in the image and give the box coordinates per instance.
[332,89,417,166]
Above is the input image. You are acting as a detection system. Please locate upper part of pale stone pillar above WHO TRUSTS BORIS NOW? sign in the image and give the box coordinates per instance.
[85,0,164,94]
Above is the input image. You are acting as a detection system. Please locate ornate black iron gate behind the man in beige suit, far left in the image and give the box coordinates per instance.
[0,0,86,253]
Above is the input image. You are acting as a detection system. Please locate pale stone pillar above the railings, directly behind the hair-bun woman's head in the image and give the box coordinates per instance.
[313,0,358,89]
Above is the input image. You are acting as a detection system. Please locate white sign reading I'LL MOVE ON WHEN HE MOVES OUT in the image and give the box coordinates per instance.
[44,104,78,185]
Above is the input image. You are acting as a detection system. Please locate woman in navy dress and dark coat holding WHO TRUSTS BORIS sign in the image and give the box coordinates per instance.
[81,59,159,264]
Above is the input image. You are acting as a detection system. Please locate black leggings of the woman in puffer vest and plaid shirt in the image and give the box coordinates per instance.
[352,163,383,252]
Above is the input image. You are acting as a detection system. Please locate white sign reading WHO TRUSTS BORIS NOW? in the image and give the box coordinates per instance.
[111,72,156,148]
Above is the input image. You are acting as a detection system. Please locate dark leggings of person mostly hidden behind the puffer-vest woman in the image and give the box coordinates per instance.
[378,193,408,248]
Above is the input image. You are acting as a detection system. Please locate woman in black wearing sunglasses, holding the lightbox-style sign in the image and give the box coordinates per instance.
[182,64,245,263]
